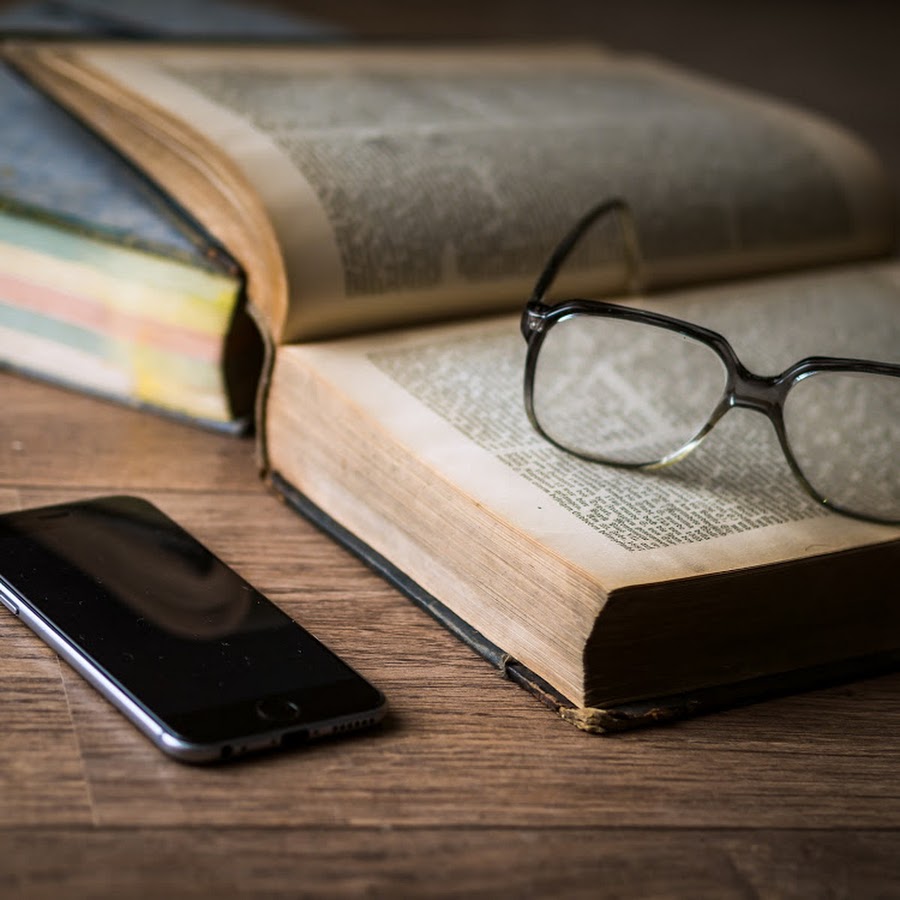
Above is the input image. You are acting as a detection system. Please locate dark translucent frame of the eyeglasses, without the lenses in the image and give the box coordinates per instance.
[521,198,900,524]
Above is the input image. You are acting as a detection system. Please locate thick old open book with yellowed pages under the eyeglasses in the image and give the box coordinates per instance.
[10,45,900,730]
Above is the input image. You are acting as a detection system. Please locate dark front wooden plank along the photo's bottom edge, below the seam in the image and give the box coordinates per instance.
[0,826,900,900]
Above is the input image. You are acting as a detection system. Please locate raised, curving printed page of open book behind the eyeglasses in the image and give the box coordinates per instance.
[12,41,891,342]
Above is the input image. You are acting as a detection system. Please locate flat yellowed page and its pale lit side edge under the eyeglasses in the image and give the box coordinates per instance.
[267,256,900,702]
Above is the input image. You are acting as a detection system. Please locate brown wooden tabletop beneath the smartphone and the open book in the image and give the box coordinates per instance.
[0,3,900,898]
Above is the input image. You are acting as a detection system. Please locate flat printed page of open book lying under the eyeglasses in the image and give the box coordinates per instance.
[270,266,900,590]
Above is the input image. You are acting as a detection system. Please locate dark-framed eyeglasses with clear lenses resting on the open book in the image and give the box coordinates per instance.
[522,199,900,524]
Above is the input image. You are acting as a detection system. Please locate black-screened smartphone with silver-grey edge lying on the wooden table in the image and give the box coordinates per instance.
[0,497,385,763]
